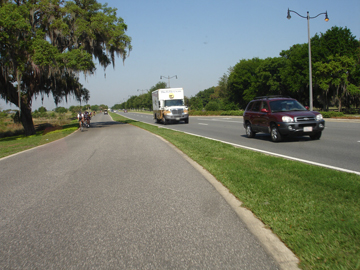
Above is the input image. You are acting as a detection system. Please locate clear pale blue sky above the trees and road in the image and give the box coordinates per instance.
[0,0,360,110]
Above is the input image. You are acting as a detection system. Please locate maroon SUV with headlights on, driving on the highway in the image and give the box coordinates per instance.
[244,96,325,142]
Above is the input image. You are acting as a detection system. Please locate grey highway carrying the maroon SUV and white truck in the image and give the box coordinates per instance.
[118,112,360,174]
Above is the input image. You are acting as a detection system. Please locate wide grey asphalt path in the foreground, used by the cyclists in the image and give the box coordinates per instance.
[0,114,296,269]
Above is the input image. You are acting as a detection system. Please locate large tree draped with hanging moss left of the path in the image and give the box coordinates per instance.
[0,0,132,135]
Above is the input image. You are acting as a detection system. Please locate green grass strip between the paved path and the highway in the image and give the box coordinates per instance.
[111,113,360,269]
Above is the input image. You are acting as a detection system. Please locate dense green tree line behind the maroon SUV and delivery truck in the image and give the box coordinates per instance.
[113,27,360,111]
